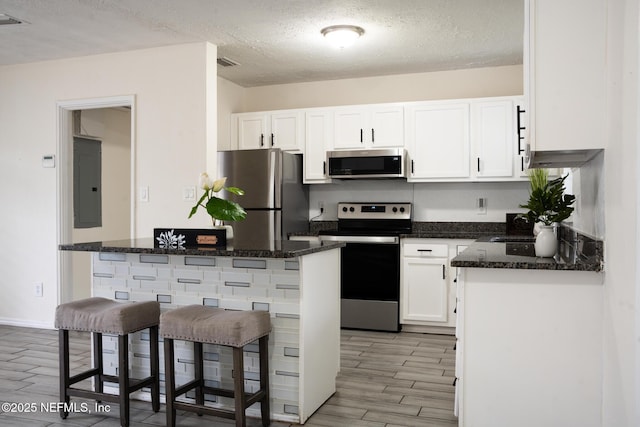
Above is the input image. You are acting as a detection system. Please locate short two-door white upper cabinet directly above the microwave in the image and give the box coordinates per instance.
[333,104,404,150]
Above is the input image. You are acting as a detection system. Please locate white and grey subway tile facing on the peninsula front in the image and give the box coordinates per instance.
[93,254,308,424]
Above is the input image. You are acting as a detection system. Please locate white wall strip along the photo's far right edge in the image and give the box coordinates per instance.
[603,0,640,427]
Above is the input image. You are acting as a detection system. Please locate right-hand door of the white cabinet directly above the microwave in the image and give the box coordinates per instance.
[364,105,404,148]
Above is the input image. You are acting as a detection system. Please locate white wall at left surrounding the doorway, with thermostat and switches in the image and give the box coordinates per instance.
[0,43,217,327]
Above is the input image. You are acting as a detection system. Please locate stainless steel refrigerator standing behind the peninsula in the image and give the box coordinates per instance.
[218,148,309,250]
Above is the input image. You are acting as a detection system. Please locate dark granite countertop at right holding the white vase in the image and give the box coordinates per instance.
[451,228,603,272]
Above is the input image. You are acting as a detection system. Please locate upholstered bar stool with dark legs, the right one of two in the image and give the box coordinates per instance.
[160,305,271,427]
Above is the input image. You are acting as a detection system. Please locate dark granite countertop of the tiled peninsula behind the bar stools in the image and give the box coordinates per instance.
[59,238,345,258]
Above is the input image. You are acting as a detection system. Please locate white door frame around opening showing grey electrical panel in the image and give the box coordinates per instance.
[56,95,136,304]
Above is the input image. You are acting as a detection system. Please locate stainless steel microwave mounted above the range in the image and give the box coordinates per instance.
[327,148,407,179]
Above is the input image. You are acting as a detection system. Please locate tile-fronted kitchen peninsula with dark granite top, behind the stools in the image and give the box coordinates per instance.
[60,239,344,423]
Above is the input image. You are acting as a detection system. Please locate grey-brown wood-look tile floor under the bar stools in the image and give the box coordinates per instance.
[0,326,457,427]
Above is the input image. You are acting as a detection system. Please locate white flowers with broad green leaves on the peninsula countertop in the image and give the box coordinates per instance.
[189,172,247,240]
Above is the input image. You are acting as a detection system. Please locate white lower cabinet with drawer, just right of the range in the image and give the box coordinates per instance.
[400,239,473,327]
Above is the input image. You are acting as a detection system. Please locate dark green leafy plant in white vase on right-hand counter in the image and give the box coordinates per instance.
[520,169,575,257]
